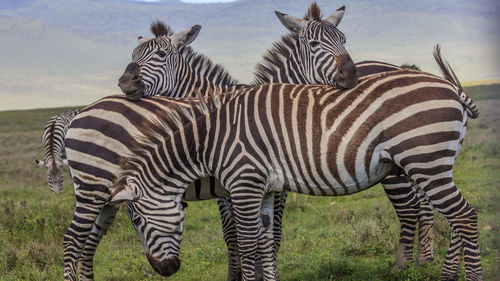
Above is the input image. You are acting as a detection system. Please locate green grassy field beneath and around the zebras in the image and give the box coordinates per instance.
[0,86,500,281]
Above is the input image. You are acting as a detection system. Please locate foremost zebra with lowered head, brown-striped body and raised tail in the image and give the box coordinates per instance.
[110,47,483,280]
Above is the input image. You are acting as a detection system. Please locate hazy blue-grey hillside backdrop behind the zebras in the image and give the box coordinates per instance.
[0,0,500,110]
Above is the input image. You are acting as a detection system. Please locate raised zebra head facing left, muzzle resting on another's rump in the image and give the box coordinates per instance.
[118,21,201,100]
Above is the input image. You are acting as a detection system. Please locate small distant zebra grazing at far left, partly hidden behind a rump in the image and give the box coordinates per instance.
[35,109,78,194]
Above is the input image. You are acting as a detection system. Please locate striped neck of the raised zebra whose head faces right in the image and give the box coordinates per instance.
[251,34,311,85]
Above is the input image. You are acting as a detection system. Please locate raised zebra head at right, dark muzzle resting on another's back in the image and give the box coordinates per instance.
[275,3,358,88]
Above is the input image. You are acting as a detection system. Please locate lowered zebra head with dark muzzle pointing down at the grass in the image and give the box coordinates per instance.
[127,183,186,276]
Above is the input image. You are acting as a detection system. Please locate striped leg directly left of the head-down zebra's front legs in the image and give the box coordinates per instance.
[216,198,242,281]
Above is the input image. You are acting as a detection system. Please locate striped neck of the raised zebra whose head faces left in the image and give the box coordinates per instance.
[169,47,238,97]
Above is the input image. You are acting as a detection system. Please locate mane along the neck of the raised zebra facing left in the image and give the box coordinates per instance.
[180,46,239,85]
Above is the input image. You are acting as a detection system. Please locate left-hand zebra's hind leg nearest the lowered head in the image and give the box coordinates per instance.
[78,205,118,281]
